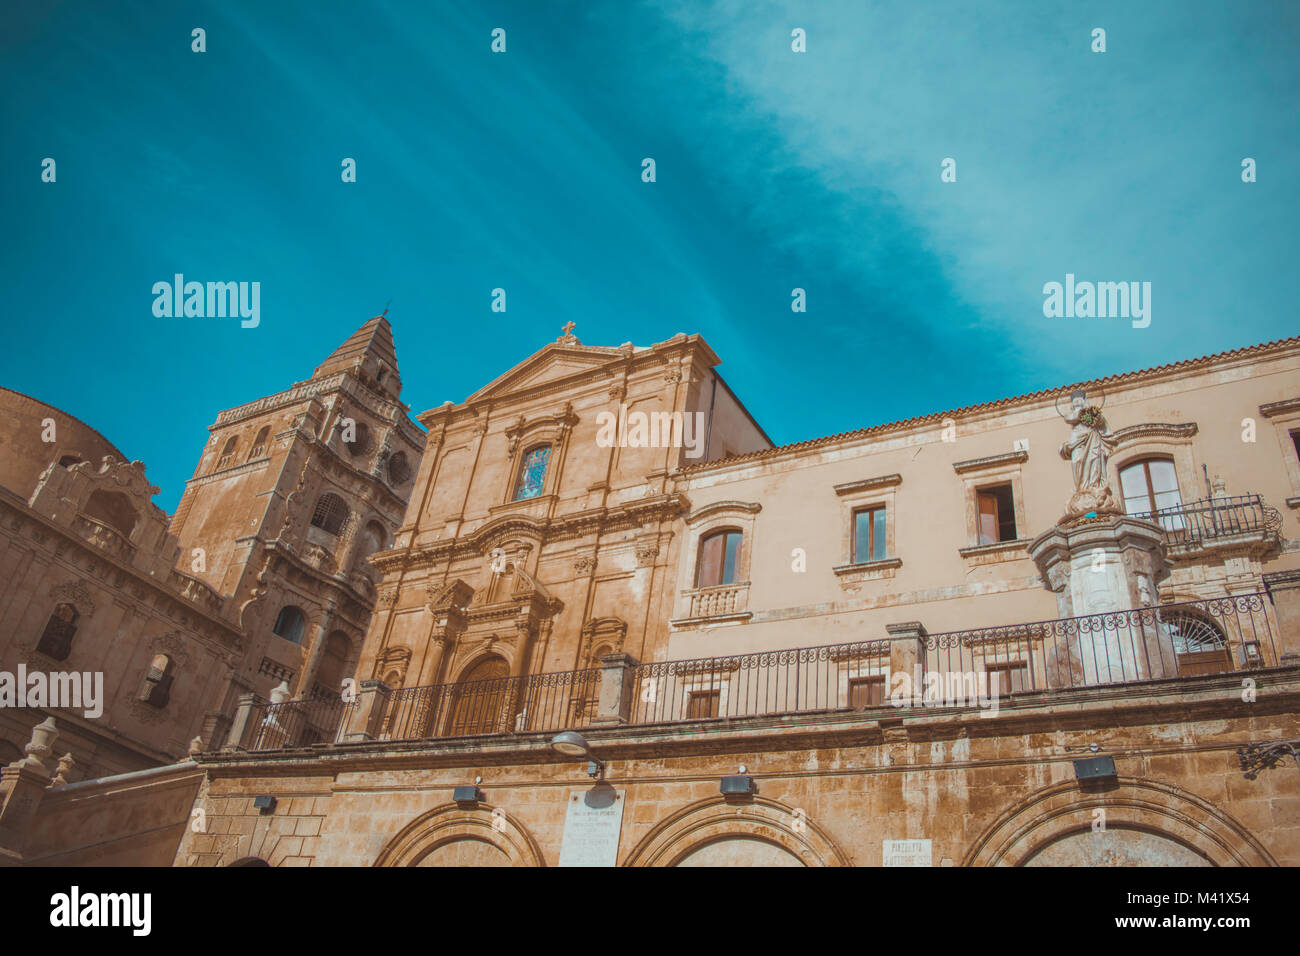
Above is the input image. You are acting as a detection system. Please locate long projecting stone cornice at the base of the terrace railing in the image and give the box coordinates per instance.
[198,666,1300,788]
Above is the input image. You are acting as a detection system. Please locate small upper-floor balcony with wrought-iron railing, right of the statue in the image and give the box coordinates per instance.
[1132,494,1282,561]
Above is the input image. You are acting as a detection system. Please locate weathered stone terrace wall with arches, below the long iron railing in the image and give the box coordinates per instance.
[176,667,1300,866]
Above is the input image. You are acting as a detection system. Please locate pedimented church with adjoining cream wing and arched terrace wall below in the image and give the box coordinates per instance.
[0,326,1300,865]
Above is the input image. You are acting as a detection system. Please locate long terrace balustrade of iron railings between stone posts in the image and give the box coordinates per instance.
[218,593,1279,750]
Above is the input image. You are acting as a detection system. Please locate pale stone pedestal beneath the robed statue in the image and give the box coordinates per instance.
[1028,515,1177,687]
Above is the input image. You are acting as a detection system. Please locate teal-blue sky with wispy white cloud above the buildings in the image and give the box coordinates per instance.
[0,0,1300,511]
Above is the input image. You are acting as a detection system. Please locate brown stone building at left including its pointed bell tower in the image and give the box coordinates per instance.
[0,317,423,779]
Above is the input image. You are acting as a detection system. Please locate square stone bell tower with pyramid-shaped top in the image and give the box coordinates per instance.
[170,316,424,710]
